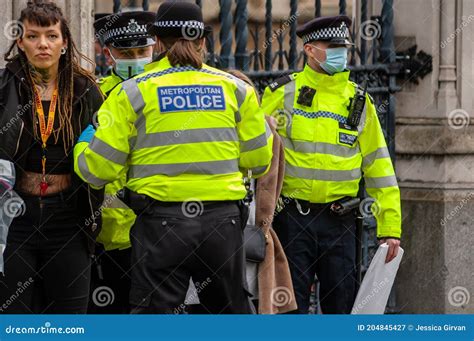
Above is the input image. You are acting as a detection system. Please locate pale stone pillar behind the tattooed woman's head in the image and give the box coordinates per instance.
[0,0,94,70]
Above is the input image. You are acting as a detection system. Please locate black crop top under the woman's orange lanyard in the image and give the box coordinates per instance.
[25,101,73,174]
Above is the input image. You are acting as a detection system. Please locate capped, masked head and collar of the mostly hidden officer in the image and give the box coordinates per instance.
[94,11,155,96]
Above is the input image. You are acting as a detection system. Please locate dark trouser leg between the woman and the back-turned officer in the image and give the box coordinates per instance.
[87,245,132,314]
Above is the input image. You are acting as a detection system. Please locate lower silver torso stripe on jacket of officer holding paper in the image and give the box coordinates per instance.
[285,162,362,181]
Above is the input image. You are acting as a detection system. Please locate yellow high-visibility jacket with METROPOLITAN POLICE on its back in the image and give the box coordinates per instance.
[74,57,273,202]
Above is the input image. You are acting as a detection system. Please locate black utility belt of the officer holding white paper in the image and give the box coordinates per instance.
[283,197,360,216]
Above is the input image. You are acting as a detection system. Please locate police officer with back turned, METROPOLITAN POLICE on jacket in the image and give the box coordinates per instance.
[75,2,272,314]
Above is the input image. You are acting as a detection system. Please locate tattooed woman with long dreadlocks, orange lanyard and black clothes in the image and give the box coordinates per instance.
[0,1,102,313]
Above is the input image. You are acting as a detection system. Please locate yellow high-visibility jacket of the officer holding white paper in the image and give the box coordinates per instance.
[262,65,401,238]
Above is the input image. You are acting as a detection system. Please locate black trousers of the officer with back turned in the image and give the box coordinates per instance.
[130,202,251,314]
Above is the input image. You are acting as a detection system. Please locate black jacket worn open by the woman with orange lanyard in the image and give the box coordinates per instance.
[0,56,104,252]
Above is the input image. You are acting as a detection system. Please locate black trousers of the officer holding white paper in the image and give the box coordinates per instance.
[273,200,356,314]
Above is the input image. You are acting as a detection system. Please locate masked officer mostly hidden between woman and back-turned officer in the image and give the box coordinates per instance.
[89,12,155,314]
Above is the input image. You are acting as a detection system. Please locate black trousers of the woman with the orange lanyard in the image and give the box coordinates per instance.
[0,193,90,314]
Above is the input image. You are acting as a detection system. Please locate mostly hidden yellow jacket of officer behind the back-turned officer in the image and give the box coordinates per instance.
[97,71,136,251]
